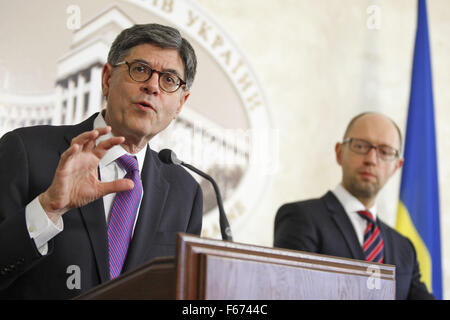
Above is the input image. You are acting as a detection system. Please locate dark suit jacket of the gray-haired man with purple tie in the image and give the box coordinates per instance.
[0,114,203,299]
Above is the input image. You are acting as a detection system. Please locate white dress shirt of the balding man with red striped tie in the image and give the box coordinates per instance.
[332,184,377,246]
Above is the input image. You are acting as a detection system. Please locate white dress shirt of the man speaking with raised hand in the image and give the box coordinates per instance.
[25,113,147,255]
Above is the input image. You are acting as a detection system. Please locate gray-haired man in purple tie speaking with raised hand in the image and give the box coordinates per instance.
[0,24,202,299]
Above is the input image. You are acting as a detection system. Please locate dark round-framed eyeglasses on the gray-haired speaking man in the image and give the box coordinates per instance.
[114,61,186,93]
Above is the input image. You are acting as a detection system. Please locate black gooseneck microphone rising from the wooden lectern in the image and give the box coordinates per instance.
[158,149,233,241]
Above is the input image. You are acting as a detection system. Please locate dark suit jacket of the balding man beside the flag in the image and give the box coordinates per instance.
[274,192,434,299]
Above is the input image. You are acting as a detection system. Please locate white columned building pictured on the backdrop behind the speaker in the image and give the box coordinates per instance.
[0,5,249,231]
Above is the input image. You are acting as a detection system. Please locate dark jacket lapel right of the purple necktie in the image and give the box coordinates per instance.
[122,146,169,272]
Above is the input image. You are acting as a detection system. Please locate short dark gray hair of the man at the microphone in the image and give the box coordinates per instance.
[108,23,197,89]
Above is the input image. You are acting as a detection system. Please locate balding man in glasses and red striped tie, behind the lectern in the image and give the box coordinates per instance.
[274,113,434,299]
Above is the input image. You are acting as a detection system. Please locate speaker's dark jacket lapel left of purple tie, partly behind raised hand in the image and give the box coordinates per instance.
[59,113,109,282]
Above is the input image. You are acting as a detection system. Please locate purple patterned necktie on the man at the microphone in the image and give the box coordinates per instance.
[108,155,142,279]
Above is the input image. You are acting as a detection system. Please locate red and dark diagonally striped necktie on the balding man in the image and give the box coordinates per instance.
[358,210,384,263]
